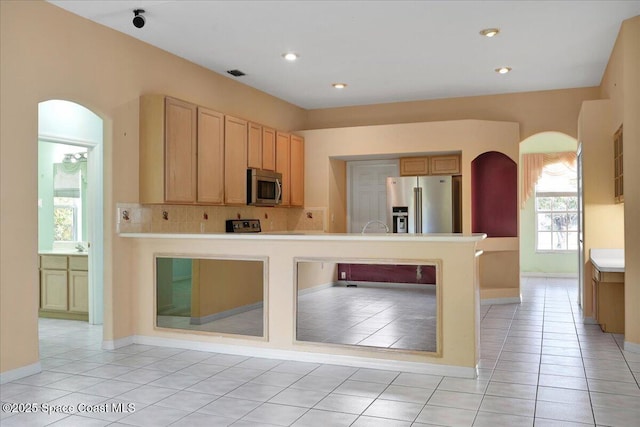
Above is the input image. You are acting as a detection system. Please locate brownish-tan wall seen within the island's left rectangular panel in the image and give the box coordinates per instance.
[191,259,265,317]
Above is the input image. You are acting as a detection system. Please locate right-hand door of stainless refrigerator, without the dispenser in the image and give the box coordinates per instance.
[418,176,453,233]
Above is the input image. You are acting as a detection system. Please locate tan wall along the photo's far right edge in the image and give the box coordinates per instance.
[600,16,640,352]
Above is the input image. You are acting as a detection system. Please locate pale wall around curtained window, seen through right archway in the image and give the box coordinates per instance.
[520,132,578,275]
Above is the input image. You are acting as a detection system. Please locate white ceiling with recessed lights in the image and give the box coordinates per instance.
[50,0,640,109]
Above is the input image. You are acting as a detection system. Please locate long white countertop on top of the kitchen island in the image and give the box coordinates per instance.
[120,231,487,243]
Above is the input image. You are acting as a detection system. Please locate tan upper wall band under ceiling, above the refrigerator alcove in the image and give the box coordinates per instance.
[306,87,599,140]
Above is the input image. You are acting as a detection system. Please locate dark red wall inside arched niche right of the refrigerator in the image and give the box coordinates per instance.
[471,151,518,237]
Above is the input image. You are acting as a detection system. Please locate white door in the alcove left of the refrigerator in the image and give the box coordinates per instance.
[347,159,400,233]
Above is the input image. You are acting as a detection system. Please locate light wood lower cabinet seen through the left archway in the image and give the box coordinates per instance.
[39,255,89,320]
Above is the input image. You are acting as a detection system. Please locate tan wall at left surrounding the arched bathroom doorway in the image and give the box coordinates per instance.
[0,1,306,372]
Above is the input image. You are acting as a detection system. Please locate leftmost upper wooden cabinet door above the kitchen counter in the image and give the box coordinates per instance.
[164,98,197,203]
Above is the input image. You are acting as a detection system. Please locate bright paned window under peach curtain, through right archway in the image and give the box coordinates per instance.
[535,163,578,252]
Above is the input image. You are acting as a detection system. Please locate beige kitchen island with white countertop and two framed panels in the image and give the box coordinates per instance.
[120,231,486,377]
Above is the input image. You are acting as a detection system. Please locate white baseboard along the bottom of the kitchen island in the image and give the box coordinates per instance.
[134,335,477,378]
